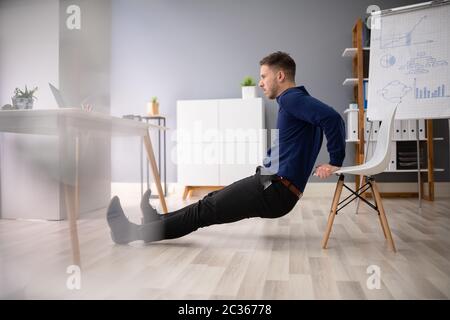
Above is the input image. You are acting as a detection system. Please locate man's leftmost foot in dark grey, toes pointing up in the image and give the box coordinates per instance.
[106,196,139,244]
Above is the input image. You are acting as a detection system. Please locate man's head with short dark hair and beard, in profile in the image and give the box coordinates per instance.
[259,51,295,99]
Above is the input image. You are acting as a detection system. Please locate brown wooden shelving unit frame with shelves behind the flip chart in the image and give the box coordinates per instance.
[342,19,444,201]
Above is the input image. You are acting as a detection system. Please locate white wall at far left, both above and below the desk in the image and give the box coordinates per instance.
[0,0,59,220]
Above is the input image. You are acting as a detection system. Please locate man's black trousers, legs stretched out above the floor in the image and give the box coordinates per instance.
[139,167,299,242]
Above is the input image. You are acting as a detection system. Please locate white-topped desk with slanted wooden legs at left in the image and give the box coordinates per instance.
[0,108,167,267]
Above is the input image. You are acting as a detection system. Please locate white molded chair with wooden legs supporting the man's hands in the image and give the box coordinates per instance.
[322,104,398,252]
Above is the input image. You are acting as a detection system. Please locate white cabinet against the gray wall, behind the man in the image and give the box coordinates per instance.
[177,98,266,186]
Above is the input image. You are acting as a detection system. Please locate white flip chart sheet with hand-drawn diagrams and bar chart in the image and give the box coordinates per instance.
[367,1,450,120]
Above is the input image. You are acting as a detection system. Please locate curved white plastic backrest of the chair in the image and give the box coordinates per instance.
[365,104,398,174]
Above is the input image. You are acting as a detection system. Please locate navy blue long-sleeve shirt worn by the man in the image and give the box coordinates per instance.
[264,86,345,192]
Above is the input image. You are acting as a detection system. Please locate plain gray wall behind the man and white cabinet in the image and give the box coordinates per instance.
[111,0,449,182]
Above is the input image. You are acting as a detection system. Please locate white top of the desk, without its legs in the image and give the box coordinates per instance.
[0,108,167,136]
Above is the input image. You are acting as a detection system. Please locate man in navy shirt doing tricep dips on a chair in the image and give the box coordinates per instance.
[107,51,345,244]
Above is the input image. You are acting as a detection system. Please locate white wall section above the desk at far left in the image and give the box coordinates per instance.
[0,0,59,109]
